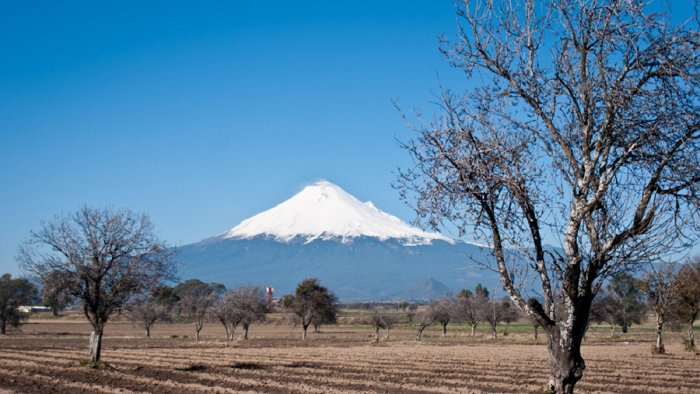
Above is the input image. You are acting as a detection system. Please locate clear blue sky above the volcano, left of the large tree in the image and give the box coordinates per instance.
[0,0,466,275]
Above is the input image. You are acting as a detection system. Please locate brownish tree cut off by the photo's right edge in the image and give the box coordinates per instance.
[671,256,700,350]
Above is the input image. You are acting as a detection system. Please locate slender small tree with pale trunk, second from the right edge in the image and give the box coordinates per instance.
[640,263,679,353]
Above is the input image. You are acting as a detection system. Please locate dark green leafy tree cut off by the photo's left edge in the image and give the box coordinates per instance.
[0,274,38,335]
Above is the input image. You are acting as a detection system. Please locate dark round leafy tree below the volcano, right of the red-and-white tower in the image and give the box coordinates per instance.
[281,278,338,340]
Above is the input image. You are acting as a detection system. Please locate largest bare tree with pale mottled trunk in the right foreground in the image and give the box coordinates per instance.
[398,0,700,393]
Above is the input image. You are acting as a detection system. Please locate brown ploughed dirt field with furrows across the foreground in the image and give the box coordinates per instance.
[0,319,700,393]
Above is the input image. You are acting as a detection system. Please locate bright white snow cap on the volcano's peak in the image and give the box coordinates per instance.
[219,181,454,245]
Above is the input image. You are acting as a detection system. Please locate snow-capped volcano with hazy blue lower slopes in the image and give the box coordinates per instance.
[179,182,490,300]
